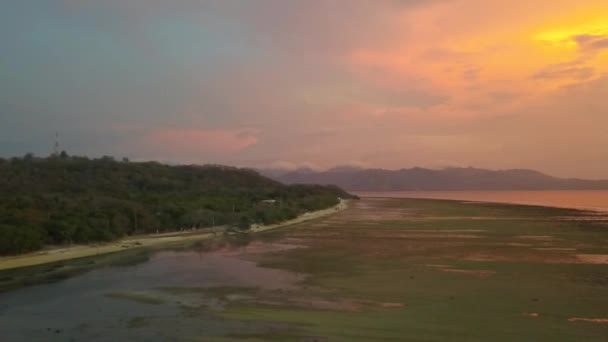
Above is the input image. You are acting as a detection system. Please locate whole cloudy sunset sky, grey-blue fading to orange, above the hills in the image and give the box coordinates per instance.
[0,0,608,178]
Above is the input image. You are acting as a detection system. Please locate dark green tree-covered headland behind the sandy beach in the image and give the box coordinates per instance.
[0,153,349,254]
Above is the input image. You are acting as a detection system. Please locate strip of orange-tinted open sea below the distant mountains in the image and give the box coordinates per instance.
[357,190,608,212]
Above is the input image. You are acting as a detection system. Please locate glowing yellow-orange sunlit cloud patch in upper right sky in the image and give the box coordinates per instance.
[349,0,608,110]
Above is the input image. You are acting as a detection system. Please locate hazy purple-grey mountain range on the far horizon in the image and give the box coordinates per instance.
[261,167,608,191]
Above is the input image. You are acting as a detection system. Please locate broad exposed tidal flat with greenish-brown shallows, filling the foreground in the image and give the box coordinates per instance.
[0,198,608,341]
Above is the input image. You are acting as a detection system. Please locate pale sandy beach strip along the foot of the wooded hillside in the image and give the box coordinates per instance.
[0,200,349,271]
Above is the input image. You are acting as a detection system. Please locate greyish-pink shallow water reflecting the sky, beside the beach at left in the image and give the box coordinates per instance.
[0,234,303,342]
